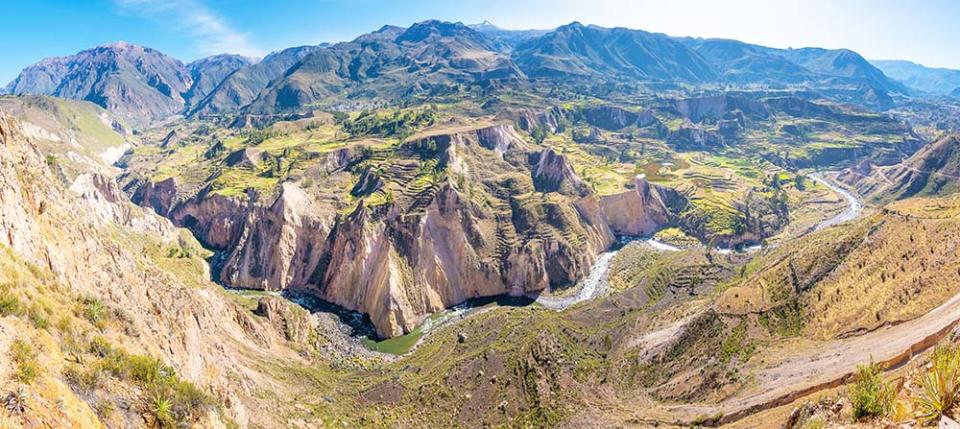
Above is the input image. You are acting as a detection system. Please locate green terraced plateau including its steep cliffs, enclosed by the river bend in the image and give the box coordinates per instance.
[114,91,881,337]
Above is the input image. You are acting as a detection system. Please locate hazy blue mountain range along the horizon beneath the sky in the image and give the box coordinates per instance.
[5,20,924,126]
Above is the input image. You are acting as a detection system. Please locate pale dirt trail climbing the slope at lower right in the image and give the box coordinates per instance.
[667,284,960,424]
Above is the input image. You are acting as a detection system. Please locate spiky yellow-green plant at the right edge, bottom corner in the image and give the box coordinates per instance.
[913,347,960,423]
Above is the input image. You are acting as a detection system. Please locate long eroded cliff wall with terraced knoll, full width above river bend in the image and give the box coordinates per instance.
[120,124,670,337]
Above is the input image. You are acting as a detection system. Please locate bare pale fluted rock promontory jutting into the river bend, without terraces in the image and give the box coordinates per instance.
[296,178,612,337]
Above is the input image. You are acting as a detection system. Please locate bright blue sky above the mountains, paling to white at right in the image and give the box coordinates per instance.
[0,0,960,83]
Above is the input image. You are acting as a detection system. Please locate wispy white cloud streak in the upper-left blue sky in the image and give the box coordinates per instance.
[114,0,264,57]
